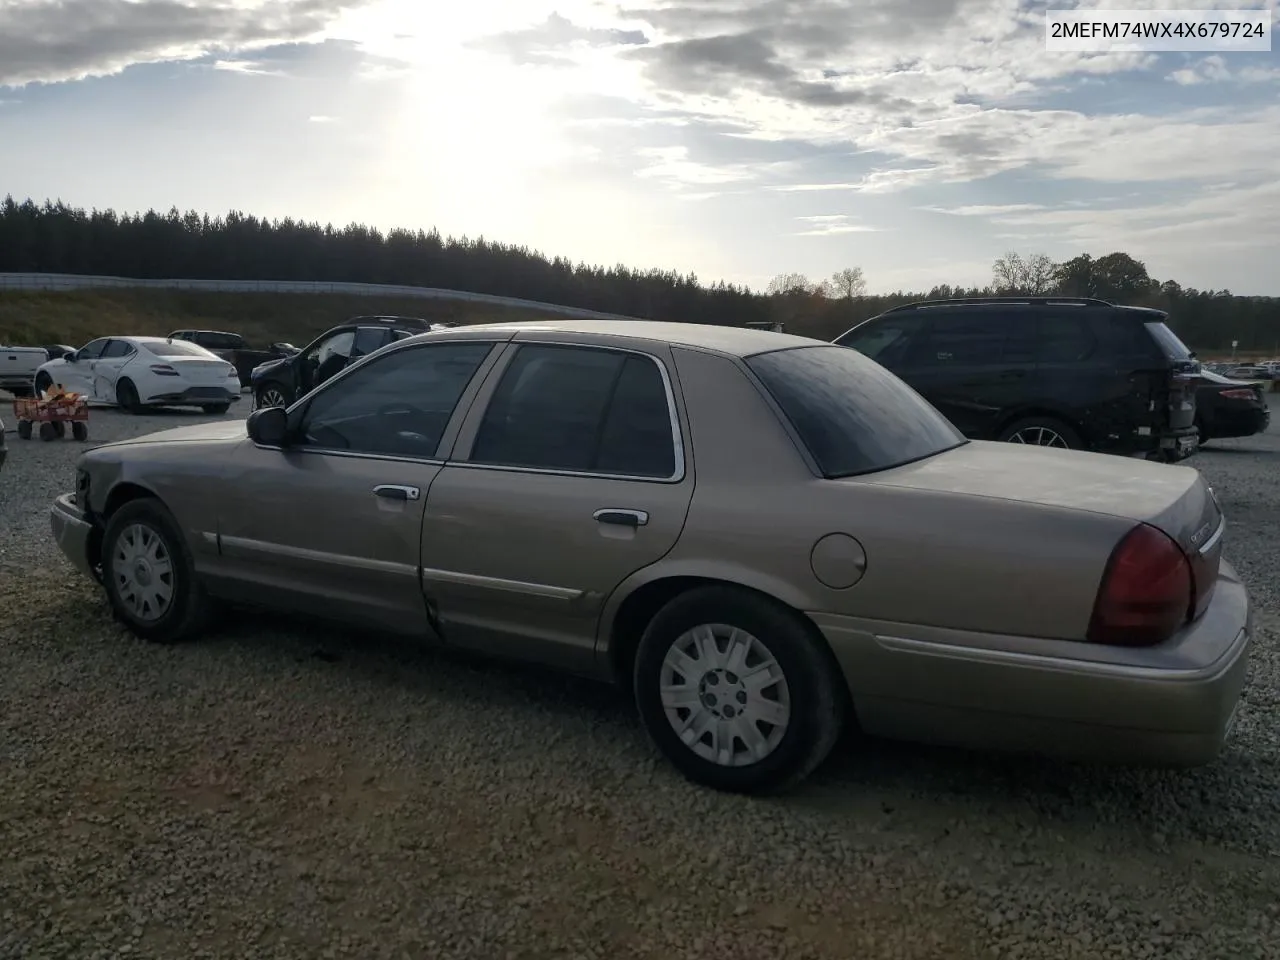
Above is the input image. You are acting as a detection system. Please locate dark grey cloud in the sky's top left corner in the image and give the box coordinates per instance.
[0,0,357,87]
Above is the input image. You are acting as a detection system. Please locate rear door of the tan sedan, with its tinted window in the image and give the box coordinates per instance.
[422,340,694,671]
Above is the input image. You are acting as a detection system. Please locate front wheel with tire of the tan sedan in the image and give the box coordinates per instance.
[102,498,209,644]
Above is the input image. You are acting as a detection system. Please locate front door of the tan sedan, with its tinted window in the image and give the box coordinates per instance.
[218,340,495,636]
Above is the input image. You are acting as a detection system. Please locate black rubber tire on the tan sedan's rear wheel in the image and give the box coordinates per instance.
[632,586,849,794]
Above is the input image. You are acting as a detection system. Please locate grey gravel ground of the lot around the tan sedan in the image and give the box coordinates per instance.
[0,394,1280,960]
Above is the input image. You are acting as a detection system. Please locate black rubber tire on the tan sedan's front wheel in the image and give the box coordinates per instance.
[102,497,209,644]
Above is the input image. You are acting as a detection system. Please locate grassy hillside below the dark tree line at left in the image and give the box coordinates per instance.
[0,289,576,347]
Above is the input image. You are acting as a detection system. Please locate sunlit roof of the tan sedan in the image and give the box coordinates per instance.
[414,319,831,357]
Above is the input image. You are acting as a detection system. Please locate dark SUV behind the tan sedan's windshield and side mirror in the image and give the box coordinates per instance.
[250,316,451,407]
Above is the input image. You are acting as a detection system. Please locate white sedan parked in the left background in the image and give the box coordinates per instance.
[35,337,241,413]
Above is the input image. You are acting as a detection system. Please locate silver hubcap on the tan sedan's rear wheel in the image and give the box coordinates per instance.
[659,623,791,767]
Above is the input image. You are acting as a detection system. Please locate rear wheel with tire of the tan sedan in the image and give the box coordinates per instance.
[634,586,847,794]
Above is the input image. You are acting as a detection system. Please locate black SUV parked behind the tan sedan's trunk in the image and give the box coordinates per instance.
[836,297,1199,461]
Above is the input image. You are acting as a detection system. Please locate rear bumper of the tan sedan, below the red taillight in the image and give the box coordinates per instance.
[813,562,1253,765]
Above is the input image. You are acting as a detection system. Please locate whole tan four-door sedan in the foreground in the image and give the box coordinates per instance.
[51,320,1252,791]
